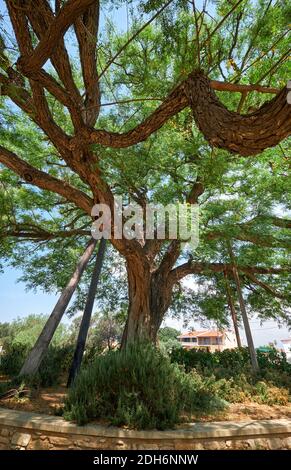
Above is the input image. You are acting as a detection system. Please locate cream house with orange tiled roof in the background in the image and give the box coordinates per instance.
[177,330,237,352]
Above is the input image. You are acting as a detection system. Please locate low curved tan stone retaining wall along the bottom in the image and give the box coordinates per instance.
[0,408,291,450]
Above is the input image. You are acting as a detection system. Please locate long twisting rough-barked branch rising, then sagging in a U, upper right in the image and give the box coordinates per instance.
[71,72,291,156]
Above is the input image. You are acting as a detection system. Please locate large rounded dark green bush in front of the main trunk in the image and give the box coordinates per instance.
[64,345,225,429]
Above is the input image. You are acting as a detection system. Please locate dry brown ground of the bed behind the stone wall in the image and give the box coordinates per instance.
[0,379,291,421]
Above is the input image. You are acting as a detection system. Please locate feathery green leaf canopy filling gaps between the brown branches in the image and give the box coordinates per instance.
[0,0,291,350]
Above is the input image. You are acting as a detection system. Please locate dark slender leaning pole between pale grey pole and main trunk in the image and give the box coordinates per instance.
[67,238,106,387]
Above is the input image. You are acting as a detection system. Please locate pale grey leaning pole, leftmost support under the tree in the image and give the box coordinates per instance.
[19,238,96,376]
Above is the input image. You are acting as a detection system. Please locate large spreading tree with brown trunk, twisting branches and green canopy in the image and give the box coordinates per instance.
[0,0,291,352]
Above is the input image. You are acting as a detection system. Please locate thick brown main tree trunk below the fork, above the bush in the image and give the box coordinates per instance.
[121,265,172,349]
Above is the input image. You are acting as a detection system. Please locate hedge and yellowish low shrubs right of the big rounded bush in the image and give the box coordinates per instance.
[171,348,291,405]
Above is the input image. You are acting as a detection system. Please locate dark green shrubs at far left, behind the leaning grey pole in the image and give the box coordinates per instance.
[0,344,73,387]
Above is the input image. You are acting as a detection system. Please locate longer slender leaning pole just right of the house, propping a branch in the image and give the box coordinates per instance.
[228,243,259,372]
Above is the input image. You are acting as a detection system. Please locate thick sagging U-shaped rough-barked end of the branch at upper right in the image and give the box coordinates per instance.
[185,72,291,156]
